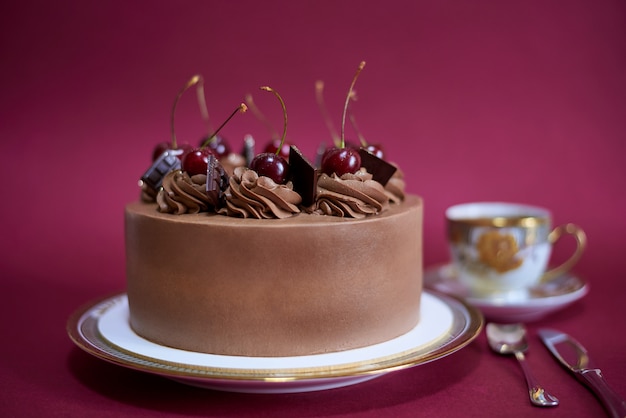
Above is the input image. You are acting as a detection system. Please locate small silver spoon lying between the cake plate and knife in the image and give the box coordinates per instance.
[486,323,559,406]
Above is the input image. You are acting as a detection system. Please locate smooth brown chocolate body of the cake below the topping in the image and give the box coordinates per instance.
[126,196,423,356]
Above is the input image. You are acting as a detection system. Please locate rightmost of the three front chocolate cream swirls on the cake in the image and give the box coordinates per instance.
[309,168,390,218]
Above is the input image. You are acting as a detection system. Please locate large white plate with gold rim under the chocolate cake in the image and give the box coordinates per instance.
[67,291,483,393]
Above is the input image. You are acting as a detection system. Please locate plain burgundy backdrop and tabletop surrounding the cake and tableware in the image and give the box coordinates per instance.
[0,0,626,417]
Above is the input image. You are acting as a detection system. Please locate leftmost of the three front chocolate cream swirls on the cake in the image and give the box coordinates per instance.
[156,170,220,215]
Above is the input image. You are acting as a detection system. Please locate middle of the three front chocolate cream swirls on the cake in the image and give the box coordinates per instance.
[218,167,302,219]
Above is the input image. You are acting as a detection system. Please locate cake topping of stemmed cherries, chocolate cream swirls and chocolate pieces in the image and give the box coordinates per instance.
[139,61,404,219]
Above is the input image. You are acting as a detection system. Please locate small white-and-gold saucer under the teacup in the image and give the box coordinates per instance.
[424,264,589,322]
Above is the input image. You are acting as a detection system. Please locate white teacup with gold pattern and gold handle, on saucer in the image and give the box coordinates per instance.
[446,202,587,300]
